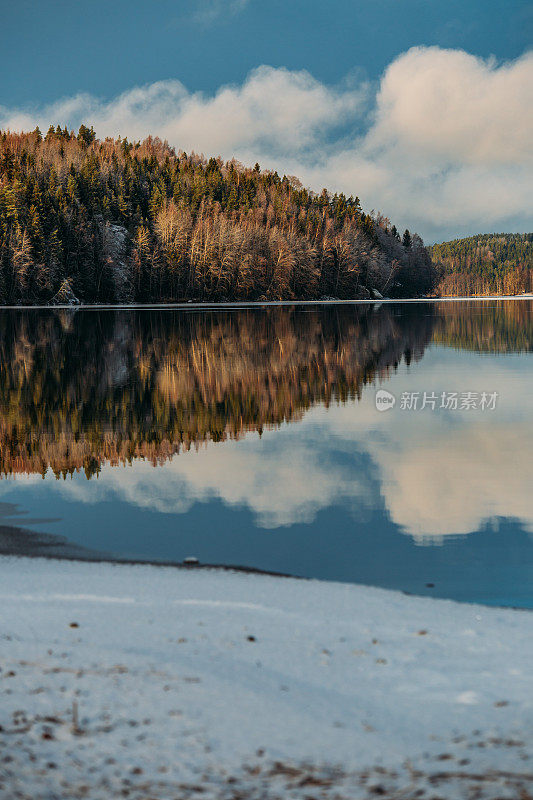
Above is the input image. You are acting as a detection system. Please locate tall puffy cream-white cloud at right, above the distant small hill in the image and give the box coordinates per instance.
[344,47,533,235]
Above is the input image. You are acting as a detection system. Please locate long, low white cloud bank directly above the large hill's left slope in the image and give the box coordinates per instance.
[0,66,365,162]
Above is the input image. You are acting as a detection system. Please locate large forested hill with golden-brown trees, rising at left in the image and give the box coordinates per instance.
[0,126,435,304]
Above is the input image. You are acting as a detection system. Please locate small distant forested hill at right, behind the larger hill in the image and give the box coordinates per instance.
[428,233,533,295]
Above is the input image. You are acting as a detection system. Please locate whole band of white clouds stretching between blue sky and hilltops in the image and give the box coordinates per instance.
[0,47,533,240]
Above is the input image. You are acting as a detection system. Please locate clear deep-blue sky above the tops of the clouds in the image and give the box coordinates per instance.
[0,0,533,106]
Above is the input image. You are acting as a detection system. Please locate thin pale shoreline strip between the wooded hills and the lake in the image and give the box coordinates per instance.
[0,294,533,311]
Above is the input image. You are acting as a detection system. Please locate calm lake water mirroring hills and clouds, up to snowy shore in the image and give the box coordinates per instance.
[0,300,533,608]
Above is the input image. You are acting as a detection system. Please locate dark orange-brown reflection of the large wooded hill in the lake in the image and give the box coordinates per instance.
[0,305,433,478]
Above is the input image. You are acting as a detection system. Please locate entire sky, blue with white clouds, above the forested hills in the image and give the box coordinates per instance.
[0,0,533,241]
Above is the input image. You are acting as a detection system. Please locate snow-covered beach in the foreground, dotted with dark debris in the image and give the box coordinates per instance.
[0,557,533,800]
